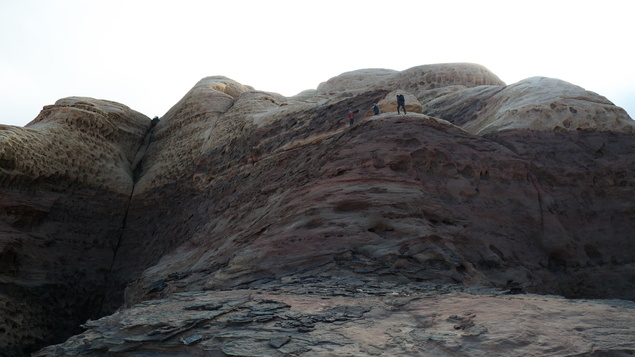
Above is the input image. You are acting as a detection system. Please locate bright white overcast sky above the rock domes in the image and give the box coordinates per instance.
[0,0,635,126]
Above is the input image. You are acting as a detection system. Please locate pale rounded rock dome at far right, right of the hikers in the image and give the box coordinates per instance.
[428,77,635,135]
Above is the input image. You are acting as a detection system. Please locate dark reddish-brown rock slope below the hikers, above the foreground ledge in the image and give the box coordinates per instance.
[121,108,635,302]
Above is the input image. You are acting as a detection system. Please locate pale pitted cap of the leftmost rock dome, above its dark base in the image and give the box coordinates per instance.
[0,97,150,194]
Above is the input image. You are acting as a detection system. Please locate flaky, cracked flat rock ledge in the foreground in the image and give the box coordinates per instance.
[34,277,635,357]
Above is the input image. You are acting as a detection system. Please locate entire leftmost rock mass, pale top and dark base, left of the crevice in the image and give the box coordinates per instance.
[0,97,150,355]
